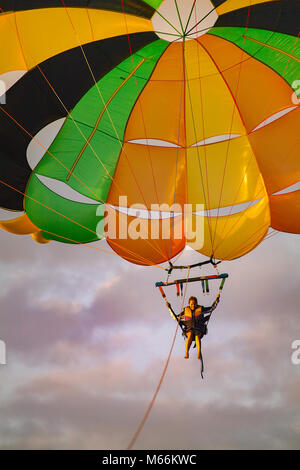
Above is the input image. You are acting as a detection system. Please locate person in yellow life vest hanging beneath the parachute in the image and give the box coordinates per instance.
[166,294,220,359]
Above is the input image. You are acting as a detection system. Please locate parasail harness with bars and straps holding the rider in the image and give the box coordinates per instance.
[155,257,228,379]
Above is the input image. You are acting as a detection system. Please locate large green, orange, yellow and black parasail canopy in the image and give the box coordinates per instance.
[0,0,300,265]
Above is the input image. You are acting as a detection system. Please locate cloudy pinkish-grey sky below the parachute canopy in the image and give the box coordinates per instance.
[0,232,300,450]
